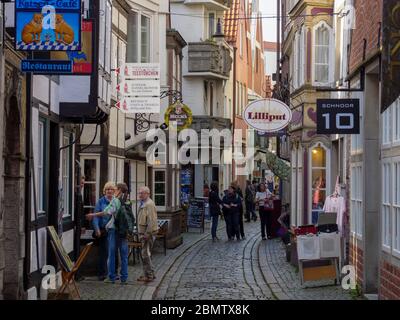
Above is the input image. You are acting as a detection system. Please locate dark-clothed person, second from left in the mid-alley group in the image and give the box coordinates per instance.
[222,185,241,240]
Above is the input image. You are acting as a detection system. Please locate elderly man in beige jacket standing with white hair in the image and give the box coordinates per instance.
[137,187,158,282]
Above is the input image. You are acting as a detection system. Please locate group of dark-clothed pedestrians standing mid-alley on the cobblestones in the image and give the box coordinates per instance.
[207,180,276,242]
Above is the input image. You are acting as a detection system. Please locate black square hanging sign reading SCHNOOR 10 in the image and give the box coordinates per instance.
[317,99,360,134]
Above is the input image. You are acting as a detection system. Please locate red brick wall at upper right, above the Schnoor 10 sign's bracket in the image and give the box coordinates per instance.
[350,0,383,73]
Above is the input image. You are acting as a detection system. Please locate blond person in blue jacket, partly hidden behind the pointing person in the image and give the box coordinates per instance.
[87,182,115,281]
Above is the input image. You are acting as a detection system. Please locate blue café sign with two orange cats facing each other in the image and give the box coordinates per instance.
[15,0,82,51]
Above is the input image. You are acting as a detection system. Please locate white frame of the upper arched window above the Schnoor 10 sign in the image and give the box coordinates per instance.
[311,20,336,87]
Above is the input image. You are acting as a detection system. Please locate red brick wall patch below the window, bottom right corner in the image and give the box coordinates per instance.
[379,260,400,300]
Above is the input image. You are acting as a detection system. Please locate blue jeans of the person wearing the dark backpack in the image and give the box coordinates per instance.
[108,229,128,282]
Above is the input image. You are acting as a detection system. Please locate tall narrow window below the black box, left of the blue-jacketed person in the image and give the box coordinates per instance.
[60,133,73,218]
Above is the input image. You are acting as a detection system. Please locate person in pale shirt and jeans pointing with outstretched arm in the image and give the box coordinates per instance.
[88,183,128,284]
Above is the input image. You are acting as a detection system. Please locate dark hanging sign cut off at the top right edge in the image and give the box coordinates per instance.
[381,0,400,112]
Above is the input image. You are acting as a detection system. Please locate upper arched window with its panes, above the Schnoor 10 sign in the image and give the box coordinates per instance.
[313,21,333,85]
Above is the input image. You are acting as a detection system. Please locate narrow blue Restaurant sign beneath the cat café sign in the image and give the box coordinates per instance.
[21,60,72,74]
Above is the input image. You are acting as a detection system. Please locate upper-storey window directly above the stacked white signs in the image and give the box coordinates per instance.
[127,11,151,63]
